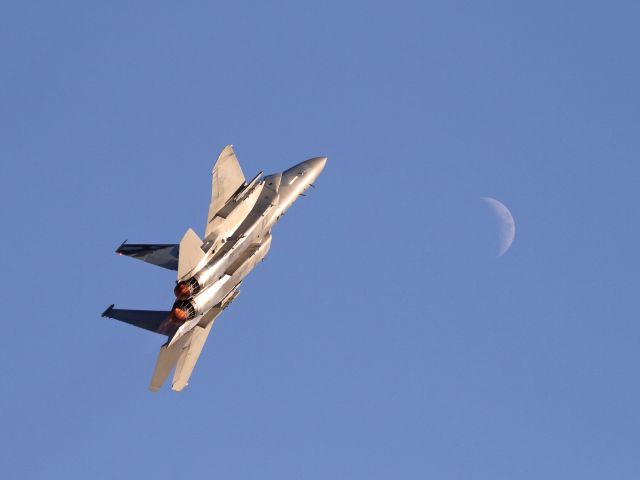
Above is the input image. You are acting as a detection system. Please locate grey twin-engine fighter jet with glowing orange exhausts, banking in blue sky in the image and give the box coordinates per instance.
[102,145,327,392]
